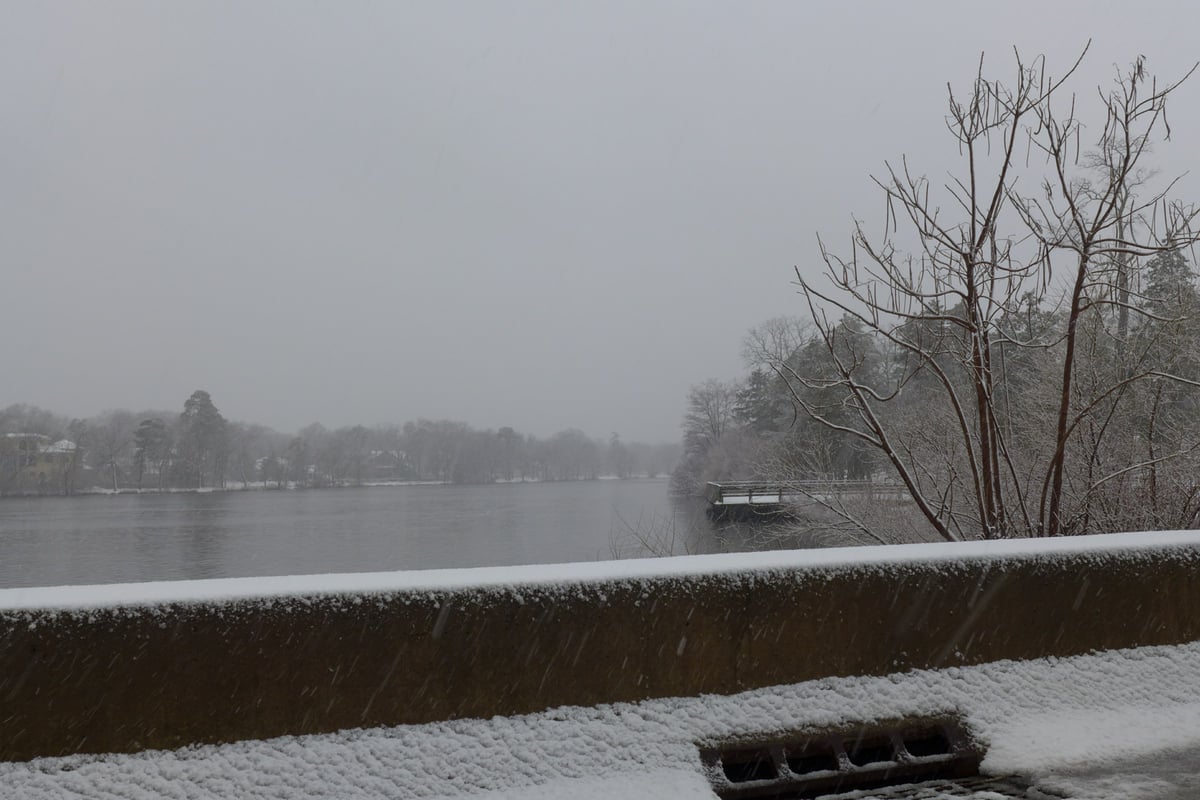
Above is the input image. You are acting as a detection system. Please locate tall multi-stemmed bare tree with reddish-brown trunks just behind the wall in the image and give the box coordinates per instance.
[784,49,1195,540]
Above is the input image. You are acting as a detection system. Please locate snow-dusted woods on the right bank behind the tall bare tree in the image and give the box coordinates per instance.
[672,251,1200,541]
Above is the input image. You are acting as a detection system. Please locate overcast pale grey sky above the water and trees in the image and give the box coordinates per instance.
[0,0,1200,440]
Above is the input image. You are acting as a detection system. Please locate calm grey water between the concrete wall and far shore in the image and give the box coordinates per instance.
[0,481,820,588]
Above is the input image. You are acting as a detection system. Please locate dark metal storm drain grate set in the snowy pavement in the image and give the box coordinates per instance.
[701,717,988,800]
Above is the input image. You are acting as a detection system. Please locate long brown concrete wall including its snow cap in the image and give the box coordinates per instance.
[0,533,1200,760]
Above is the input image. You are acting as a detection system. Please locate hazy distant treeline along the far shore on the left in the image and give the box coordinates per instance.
[0,390,680,494]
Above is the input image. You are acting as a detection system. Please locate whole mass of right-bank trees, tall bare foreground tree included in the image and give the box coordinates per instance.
[674,55,1200,542]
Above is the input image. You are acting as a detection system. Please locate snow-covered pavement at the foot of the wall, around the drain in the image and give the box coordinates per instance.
[0,642,1200,800]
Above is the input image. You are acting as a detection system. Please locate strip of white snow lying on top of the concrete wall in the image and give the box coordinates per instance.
[0,530,1200,613]
